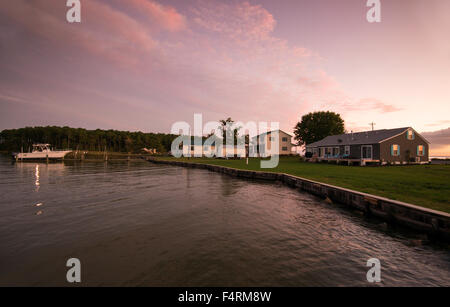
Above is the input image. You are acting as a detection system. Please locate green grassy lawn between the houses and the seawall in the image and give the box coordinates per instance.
[158,157,450,213]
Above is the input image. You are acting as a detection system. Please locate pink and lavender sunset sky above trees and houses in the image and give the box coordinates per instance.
[0,0,450,155]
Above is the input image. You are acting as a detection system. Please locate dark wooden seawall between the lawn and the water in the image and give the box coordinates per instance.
[147,159,450,242]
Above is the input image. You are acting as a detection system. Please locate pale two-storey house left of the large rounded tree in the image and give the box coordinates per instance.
[249,130,297,157]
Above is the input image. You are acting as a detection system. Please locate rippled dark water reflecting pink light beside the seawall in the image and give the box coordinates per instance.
[0,157,450,286]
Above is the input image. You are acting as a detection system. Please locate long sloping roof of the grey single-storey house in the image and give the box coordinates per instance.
[306,127,410,147]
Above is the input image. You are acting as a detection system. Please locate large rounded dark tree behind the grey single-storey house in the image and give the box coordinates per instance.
[294,111,344,145]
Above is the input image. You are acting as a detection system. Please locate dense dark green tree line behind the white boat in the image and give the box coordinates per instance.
[0,126,177,153]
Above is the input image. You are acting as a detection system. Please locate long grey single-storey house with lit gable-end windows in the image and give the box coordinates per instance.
[306,127,430,165]
